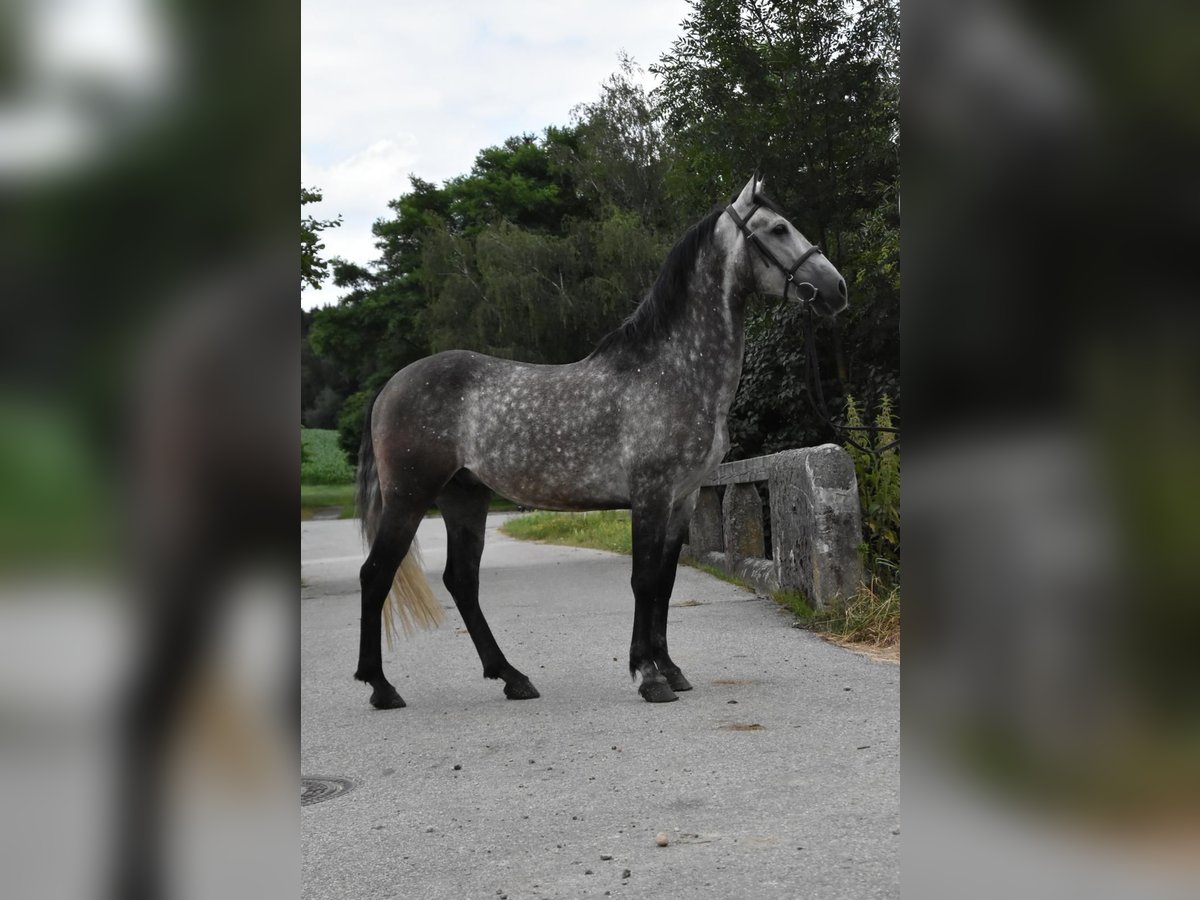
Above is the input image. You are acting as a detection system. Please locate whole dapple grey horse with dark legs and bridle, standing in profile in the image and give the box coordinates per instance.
[355,178,846,709]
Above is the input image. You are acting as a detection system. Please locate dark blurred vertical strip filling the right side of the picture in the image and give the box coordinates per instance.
[902,0,1200,898]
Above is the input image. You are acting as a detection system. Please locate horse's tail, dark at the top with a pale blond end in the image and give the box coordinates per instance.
[356,394,445,650]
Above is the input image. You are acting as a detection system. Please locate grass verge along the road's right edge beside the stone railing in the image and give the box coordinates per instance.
[500,510,900,655]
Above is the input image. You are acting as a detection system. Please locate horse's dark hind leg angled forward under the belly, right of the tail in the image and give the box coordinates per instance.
[437,470,541,700]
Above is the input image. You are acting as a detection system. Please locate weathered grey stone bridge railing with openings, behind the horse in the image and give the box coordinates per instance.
[684,444,863,608]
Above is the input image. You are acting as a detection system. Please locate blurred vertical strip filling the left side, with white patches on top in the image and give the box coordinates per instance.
[0,0,299,899]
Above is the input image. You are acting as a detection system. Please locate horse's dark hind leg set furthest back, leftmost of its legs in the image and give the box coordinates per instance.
[354,504,426,709]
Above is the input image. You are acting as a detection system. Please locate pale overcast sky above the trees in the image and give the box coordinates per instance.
[300,0,690,308]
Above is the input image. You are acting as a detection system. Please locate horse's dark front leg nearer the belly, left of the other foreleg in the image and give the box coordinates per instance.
[629,500,678,703]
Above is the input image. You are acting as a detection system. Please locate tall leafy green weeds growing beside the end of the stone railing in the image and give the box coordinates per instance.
[846,395,900,590]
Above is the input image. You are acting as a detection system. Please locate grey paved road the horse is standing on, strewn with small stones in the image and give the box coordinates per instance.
[300,517,900,900]
